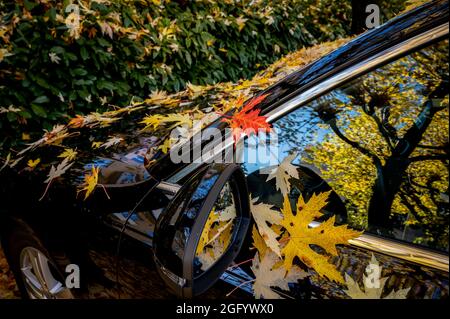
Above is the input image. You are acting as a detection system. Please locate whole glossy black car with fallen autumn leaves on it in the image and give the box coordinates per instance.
[0,1,449,299]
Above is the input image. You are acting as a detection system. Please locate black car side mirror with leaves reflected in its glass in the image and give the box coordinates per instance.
[153,164,250,298]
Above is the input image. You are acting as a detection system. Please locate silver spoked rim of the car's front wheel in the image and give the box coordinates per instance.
[20,247,73,299]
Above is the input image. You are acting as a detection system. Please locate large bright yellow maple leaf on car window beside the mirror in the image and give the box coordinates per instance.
[281,192,361,283]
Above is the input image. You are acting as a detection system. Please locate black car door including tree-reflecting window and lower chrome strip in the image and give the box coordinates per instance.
[239,30,449,298]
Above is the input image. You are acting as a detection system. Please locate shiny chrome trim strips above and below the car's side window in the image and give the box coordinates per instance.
[162,22,449,272]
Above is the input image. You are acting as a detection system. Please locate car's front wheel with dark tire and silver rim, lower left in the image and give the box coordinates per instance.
[2,220,74,299]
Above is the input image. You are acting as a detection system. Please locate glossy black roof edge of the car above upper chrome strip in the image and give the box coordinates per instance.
[255,0,449,114]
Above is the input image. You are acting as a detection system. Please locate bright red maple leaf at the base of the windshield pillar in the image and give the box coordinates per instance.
[222,94,271,143]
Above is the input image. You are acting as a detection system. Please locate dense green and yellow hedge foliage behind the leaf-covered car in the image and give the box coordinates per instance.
[0,0,404,148]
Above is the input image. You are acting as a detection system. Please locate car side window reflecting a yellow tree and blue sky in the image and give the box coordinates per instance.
[243,40,449,251]
